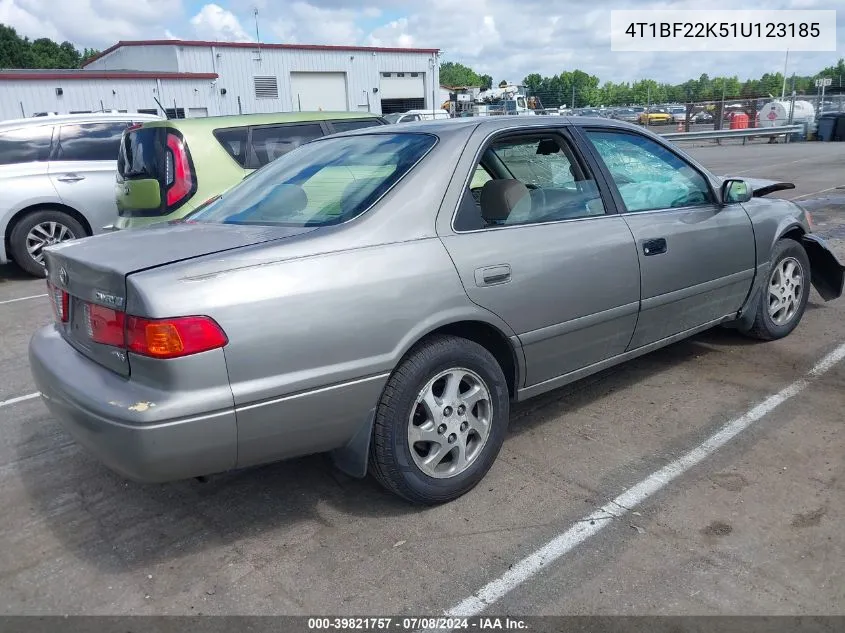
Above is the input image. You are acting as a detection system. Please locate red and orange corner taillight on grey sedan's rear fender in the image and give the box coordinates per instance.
[126,316,229,358]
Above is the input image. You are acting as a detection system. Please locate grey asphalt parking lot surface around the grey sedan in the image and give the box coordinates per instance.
[0,143,845,615]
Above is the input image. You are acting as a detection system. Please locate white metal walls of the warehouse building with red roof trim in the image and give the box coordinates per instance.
[0,43,441,120]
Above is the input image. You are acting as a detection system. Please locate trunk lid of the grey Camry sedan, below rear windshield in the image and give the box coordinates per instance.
[44,223,315,376]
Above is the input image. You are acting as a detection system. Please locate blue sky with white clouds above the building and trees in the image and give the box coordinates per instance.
[0,0,845,82]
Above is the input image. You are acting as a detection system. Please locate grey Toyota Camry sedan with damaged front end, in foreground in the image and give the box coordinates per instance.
[30,117,845,504]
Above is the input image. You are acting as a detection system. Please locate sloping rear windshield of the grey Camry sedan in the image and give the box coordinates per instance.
[186,134,436,226]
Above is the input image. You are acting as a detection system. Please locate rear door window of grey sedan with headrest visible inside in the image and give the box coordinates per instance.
[455,134,605,231]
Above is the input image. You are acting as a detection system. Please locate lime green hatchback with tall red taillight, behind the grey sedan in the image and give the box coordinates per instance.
[114,112,387,229]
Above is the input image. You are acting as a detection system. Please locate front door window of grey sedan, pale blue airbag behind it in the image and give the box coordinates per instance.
[585,130,714,212]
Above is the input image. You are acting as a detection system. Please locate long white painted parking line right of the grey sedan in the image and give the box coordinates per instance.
[445,344,845,617]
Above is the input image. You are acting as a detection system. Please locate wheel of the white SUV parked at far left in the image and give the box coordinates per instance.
[9,209,86,277]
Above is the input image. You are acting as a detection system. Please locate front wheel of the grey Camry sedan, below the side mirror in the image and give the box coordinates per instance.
[748,238,810,341]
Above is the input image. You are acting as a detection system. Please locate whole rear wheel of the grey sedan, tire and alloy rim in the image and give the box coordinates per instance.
[370,336,509,504]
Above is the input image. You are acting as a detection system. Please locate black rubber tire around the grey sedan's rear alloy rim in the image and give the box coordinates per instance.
[369,336,510,505]
